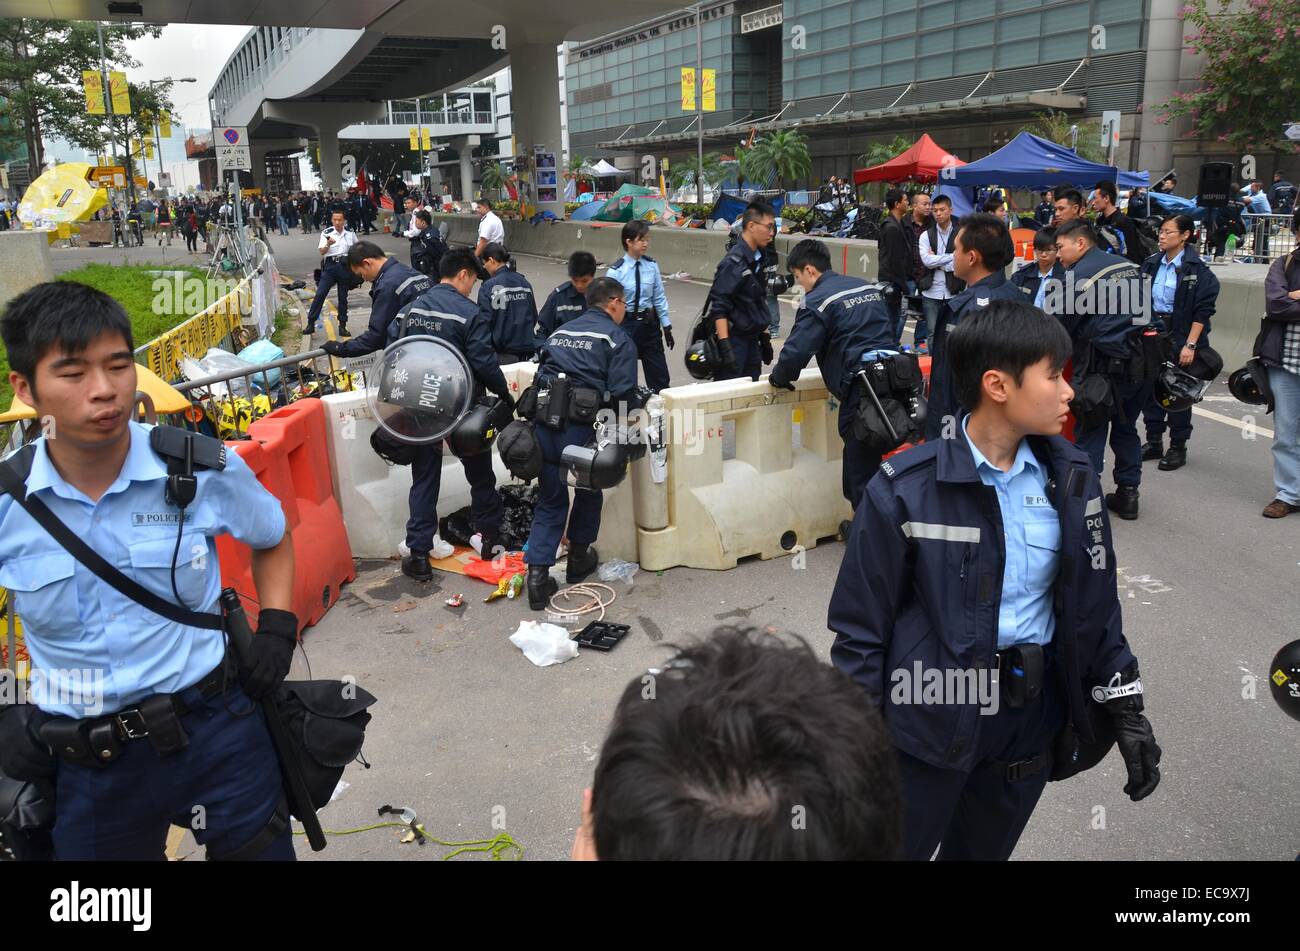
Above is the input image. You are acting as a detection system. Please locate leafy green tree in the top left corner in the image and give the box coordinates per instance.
[0,17,163,178]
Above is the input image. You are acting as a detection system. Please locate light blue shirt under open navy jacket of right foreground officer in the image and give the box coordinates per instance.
[962,416,1061,651]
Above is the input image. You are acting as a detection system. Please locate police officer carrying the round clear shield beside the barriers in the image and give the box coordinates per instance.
[325,249,515,581]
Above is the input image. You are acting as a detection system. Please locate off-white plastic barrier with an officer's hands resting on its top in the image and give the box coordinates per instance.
[633,370,850,570]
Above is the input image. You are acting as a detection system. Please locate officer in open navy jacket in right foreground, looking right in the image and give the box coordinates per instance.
[827,300,1161,861]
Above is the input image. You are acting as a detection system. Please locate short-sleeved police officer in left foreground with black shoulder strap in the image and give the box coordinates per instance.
[0,282,298,860]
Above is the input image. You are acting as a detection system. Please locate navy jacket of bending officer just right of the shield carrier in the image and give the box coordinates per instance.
[537,307,637,404]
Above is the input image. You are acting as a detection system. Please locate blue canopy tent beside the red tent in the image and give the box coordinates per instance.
[941,133,1151,191]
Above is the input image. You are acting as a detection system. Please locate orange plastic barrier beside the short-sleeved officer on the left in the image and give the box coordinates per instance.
[217,399,356,633]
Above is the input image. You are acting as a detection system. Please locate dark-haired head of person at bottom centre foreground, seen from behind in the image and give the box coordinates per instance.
[573,628,901,861]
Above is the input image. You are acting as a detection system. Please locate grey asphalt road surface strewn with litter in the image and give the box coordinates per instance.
[43,224,1300,861]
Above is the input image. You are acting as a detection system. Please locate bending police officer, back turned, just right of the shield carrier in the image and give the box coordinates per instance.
[524,277,638,611]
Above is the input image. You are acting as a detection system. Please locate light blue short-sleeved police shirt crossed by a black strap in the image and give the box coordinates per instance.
[0,422,285,717]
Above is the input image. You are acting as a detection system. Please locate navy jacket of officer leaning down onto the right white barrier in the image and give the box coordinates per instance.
[770,270,896,400]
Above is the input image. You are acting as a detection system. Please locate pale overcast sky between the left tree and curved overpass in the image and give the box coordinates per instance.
[129,23,248,129]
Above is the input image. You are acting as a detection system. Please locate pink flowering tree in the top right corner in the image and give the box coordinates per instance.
[1156,0,1300,151]
